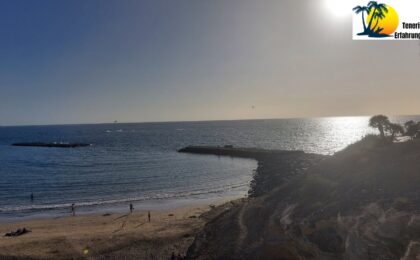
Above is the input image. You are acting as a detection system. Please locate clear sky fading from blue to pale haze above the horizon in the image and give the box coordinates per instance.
[0,0,420,125]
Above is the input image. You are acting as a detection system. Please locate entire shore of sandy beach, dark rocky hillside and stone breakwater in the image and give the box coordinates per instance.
[0,142,420,260]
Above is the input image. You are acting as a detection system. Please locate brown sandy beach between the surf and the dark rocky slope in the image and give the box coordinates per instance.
[0,202,230,259]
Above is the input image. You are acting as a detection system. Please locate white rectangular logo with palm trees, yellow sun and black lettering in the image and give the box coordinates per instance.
[353,0,420,40]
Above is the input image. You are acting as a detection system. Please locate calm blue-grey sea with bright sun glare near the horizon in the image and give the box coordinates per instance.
[0,117,420,221]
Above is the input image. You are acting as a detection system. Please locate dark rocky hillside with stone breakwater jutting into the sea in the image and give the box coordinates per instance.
[178,136,420,260]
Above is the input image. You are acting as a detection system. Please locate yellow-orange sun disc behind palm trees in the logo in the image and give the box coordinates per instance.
[366,5,399,34]
